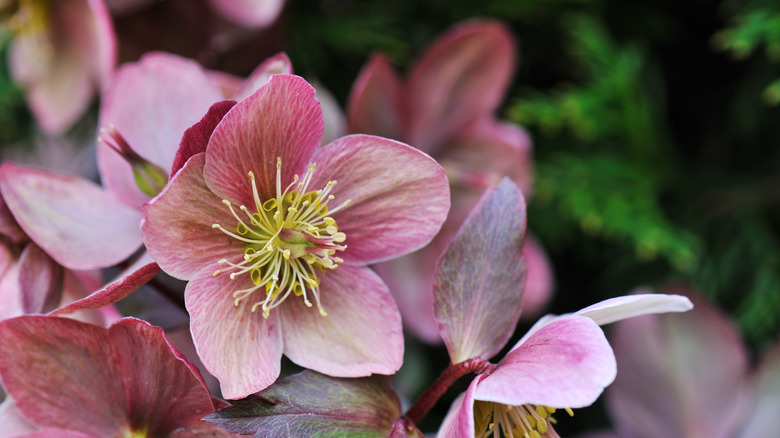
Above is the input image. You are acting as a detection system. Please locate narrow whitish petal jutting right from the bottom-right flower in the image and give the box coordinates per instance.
[574,293,693,325]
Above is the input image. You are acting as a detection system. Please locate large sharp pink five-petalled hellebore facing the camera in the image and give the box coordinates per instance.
[142,75,449,399]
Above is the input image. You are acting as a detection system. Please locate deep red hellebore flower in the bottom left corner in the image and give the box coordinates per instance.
[0,316,235,438]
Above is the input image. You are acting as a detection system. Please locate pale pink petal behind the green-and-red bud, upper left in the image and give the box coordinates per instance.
[97,53,223,206]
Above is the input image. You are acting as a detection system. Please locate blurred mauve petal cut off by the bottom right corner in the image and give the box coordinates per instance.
[737,343,780,438]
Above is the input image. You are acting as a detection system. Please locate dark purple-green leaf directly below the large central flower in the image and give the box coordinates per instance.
[204,370,401,438]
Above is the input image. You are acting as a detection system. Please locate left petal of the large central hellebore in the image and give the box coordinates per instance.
[141,154,244,280]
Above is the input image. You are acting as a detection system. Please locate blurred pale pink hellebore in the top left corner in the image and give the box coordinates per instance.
[0,0,116,134]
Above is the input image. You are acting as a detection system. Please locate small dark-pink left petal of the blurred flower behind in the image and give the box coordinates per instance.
[347,55,406,141]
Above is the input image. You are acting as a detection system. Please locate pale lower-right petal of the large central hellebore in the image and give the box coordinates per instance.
[278,265,404,377]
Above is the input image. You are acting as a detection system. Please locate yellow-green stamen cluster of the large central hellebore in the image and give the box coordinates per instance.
[212,158,350,318]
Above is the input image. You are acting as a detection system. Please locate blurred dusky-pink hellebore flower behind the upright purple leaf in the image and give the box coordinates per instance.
[347,21,553,342]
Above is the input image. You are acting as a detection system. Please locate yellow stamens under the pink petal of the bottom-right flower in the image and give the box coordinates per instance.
[474,400,574,438]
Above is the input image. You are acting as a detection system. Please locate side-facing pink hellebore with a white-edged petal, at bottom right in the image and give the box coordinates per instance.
[438,294,692,438]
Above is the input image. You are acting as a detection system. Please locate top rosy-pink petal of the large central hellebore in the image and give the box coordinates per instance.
[203,75,324,206]
